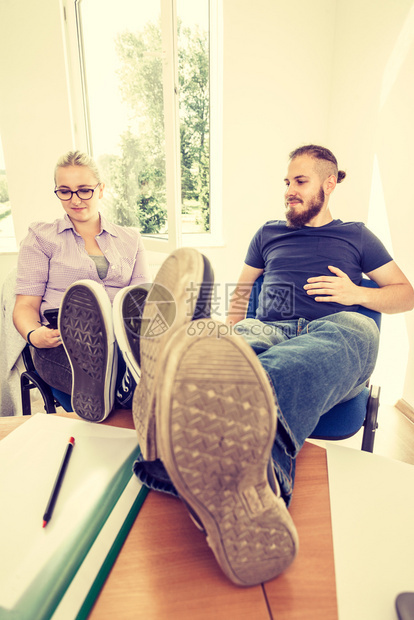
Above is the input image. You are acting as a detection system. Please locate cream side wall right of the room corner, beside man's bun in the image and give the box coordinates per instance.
[329,0,414,406]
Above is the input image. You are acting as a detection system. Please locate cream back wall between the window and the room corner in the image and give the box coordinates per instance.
[204,0,335,304]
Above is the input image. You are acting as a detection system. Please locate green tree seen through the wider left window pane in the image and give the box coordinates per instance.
[116,23,167,234]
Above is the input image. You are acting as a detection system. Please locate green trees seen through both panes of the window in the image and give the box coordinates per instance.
[111,18,209,233]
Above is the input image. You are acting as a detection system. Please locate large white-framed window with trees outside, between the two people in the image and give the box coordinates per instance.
[66,0,221,251]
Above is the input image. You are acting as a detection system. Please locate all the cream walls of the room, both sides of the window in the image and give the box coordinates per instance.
[0,0,414,404]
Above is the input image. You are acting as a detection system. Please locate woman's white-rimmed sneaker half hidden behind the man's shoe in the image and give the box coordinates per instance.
[112,284,151,385]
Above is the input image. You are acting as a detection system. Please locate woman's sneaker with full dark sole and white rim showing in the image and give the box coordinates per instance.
[59,280,117,422]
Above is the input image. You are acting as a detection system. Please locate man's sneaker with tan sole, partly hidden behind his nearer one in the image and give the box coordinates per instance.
[132,248,214,461]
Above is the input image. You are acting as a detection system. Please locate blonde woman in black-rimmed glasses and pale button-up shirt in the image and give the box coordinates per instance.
[13,151,149,421]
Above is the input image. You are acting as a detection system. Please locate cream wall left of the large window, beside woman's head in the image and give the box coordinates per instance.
[0,0,73,242]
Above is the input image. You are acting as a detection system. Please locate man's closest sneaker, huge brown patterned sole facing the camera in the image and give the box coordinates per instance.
[157,319,298,586]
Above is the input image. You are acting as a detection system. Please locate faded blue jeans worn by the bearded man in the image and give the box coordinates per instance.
[134,311,379,505]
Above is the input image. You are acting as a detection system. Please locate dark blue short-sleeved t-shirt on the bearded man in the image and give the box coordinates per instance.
[245,220,392,321]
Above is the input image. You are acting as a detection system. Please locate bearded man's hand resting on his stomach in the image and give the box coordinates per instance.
[303,265,360,306]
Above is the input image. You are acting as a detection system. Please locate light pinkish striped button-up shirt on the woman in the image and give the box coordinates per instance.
[16,214,150,320]
